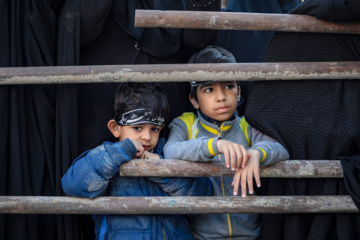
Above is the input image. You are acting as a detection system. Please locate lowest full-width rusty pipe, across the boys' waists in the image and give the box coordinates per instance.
[0,196,359,214]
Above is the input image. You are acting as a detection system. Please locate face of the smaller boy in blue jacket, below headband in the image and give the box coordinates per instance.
[113,124,164,151]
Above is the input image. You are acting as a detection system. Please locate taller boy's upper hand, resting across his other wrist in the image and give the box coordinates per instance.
[217,139,250,171]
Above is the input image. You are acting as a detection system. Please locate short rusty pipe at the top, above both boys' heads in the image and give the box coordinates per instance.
[135,10,360,34]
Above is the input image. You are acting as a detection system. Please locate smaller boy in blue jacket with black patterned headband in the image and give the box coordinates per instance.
[62,83,211,240]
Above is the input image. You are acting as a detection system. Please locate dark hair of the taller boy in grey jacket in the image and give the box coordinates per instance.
[188,46,236,101]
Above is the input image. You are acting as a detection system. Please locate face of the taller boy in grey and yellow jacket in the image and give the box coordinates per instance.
[190,82,240,122]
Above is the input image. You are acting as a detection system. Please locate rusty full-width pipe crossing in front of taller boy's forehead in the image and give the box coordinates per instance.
[0,61,360,85]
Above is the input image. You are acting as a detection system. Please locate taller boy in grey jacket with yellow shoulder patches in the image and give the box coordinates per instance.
[164,46,289,239]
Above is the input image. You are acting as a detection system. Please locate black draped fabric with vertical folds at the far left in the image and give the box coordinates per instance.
[0,0,80,240]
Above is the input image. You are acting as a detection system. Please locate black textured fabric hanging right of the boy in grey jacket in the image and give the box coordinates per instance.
[245,0,360,240]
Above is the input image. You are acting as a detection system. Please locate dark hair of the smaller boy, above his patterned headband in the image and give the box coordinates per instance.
[114,82,170,124]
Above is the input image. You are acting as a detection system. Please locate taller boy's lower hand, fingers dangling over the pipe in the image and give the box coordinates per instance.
[231,149,261,197]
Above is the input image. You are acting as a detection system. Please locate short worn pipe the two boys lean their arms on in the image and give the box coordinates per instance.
[120,159,343,178]
